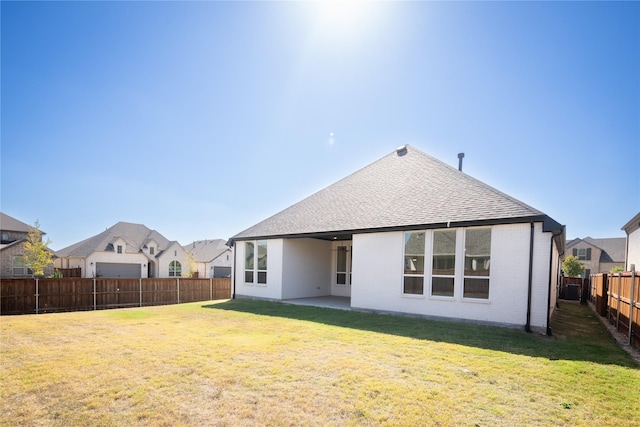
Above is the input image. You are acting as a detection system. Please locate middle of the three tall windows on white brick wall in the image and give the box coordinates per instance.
[431,230,456,297]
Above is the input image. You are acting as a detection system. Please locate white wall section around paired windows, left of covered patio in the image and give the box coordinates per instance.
[233,239,284,300]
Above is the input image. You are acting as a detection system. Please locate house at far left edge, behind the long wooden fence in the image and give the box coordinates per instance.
[0,212,53,278]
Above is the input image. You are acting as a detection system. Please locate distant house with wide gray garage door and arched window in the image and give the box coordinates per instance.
[55,222,190,278]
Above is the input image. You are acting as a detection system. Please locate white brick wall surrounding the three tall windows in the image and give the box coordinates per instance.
[351,224,551,329]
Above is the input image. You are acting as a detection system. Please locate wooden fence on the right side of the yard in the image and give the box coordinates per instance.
[591,271,640,349]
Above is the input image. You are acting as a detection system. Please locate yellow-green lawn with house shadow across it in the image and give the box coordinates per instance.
[0,300,640,426]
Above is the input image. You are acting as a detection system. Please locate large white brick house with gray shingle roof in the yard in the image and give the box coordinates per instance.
[231,146,565,333]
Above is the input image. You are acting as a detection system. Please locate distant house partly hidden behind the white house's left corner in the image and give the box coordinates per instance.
[183,239,233,278]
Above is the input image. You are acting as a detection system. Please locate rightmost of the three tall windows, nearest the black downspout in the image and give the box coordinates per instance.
[462,228,491,299]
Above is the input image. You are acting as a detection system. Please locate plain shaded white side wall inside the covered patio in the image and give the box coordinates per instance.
[282,239,332,299]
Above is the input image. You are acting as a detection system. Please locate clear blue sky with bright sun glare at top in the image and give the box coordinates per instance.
[0,1,640,249]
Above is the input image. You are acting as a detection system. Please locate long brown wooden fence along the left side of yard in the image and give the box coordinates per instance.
[0,278,231,314]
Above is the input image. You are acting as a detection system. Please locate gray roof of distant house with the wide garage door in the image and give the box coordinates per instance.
[56,222,171,258]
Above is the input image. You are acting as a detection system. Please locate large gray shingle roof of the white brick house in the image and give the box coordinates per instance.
[232,146,546,240]
